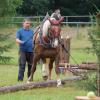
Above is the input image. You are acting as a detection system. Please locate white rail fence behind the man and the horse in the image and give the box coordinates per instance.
[12,16,92,25]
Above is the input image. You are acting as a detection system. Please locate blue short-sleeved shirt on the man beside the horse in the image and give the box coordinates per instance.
[16,28,34,52]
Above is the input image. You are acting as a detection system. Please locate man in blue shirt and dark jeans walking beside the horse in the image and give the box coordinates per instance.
[16,19,34,81]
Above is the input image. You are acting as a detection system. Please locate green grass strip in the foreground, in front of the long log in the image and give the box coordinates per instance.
[0,87,86,100]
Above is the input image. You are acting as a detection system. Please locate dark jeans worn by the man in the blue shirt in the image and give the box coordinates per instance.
[18,51,33,81]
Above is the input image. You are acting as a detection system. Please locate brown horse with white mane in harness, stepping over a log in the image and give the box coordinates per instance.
[28,14,63,85]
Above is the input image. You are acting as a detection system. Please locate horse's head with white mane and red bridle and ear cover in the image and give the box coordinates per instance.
[42,16,63,48]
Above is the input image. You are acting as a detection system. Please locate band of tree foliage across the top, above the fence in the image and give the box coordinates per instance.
[0,0,100,17]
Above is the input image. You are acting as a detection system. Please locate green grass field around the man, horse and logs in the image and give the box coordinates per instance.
[0,26,96,100]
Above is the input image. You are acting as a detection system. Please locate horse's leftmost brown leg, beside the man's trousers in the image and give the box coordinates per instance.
[28,55,40,82]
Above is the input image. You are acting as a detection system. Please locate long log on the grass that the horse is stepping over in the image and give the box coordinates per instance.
[0,76,82,94]
